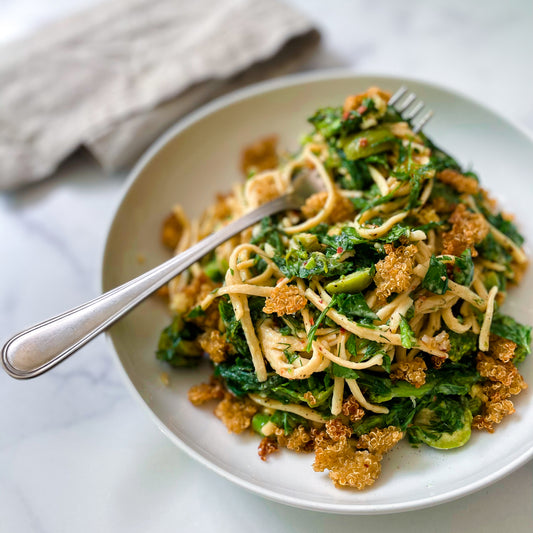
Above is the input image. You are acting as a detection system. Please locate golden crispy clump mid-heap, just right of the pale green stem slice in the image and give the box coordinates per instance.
[374,244,417,300]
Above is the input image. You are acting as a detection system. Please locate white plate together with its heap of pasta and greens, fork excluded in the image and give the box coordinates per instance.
[103,73,533,514]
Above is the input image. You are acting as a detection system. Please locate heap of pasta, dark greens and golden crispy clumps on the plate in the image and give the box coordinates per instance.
[158,88,530,489]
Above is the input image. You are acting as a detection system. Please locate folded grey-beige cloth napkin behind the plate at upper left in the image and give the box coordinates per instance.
[0,0,319,189]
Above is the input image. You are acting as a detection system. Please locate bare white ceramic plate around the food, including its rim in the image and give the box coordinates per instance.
[103,72,533,514]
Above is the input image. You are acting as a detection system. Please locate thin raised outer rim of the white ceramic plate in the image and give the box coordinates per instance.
[100,68,533,515]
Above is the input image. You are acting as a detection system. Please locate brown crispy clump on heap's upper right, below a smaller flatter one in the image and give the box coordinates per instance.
[442,204,489,257]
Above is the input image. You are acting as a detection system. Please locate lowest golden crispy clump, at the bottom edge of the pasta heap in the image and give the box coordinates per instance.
[313,440,381,490]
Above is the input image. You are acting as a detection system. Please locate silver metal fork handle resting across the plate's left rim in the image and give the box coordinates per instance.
[2,195,295,379]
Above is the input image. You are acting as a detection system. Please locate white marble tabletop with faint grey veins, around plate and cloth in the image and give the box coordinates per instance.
[0,0,533,533]
